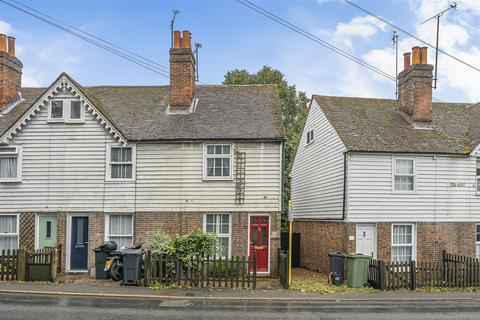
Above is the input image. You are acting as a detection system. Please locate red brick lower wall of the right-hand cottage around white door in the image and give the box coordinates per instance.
[293,221,476,274]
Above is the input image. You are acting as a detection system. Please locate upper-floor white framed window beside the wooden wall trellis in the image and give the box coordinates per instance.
[203,144,232,180]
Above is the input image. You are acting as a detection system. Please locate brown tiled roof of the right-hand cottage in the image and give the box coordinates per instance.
[313,95,474,154]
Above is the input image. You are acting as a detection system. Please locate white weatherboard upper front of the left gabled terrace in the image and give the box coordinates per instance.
[0,108,282,213]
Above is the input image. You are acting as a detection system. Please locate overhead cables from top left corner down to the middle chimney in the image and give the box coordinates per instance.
[0,0,169,78]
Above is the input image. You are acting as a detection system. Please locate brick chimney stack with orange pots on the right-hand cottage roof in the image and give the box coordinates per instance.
[398,47,433,126]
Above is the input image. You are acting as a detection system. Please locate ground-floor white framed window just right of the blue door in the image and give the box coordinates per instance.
[105,214,133,249]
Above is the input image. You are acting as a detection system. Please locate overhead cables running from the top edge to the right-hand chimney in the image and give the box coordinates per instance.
[236,0,441,102]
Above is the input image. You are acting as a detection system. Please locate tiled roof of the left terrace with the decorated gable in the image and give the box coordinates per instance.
[0,74,284,141]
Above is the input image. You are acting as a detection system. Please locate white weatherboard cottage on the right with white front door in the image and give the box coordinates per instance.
[291,47,480,272]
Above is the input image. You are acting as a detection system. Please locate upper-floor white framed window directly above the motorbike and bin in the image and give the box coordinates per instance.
[106,145,136,181]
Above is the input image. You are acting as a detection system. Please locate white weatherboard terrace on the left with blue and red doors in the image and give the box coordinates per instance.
[0,33,283,273]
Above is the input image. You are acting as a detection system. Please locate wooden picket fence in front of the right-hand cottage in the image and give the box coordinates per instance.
[368,251,480,290]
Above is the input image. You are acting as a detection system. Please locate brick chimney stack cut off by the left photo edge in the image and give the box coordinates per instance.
[0,34,23,111]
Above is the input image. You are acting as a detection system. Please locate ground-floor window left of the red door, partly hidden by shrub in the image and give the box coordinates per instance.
[203,213,232,257]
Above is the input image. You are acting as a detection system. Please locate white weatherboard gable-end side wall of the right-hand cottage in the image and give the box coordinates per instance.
[291,100,346,219]
